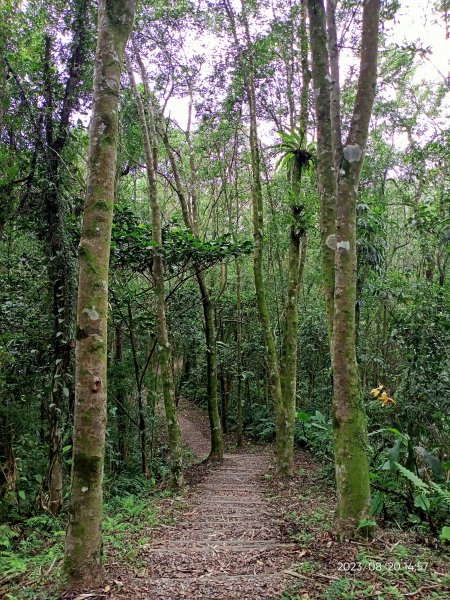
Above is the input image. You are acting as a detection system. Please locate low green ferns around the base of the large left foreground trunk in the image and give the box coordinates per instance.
[0,478,178,600]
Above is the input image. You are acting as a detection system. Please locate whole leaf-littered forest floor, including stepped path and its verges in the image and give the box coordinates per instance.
[0,403,450,600]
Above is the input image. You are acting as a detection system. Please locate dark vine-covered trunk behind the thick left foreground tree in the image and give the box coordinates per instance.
[41,0,89,515]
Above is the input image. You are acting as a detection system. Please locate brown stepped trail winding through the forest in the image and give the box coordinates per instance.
[120,403,296,600]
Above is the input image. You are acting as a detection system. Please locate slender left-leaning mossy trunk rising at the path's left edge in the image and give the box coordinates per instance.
[127,55,183,487]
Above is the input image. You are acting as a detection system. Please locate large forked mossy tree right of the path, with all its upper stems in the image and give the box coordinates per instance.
[308,0,380,535]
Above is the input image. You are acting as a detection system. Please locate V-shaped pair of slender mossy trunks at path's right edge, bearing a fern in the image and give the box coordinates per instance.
[223,0,309,476]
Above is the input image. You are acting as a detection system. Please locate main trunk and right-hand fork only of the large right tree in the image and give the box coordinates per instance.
[332,0,380,533]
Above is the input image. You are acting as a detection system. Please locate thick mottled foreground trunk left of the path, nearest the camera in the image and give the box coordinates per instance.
[64,0,136,585]
